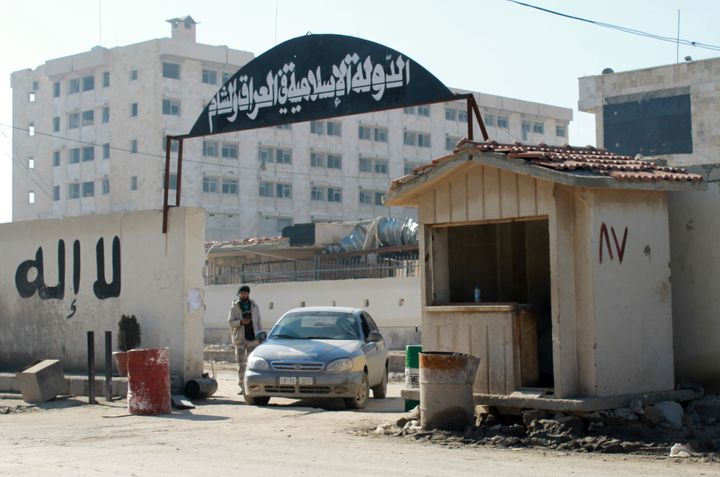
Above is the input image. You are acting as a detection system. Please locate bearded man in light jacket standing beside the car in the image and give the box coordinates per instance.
[228,285,262,392]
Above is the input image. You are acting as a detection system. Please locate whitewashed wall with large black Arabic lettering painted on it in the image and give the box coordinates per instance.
[0,208,205,379]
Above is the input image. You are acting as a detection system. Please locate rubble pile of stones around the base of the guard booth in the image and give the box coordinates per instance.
[373,396,720,462]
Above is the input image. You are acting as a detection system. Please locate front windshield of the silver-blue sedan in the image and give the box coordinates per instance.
[268,312,359,340]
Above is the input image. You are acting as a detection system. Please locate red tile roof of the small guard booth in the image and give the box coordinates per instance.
[390,139,702,191]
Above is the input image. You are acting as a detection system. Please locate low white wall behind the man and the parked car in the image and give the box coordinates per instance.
[205,277,420,348]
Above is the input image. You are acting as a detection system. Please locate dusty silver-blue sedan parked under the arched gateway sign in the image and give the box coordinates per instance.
[243,307,388,409]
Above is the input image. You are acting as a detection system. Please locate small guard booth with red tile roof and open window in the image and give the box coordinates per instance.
[385,140,704,410]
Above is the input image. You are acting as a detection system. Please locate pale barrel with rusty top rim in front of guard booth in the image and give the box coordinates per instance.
[420,351,480,430]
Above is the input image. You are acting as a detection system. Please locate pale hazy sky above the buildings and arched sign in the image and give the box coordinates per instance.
[0,0,720,222]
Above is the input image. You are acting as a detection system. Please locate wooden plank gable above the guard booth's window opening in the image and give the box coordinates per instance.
[418,165,553,225]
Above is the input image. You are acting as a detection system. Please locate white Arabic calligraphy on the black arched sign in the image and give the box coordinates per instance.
[208,53,410,132]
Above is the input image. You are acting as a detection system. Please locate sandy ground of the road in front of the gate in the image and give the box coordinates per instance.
[0,367,720,477]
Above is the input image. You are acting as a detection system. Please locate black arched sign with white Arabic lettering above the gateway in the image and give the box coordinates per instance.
[184,34,465,137]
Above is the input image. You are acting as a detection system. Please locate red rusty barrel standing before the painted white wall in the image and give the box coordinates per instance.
[128,348,171,416]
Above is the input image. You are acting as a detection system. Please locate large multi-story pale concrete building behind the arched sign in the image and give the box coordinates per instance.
[12,17,572,240]
